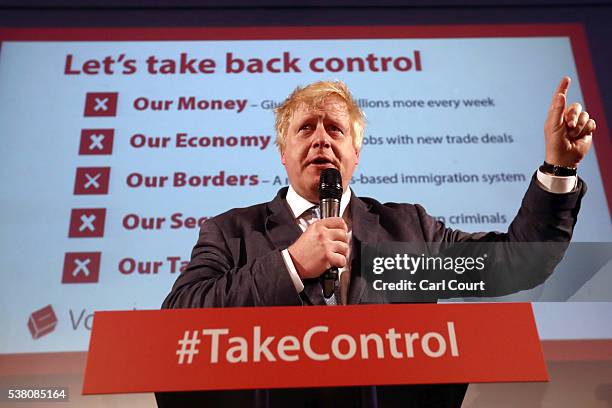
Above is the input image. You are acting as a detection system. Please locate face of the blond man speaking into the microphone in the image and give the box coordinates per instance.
[281,97,359,202]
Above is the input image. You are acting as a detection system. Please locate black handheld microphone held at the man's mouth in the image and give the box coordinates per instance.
[319,168,342,299]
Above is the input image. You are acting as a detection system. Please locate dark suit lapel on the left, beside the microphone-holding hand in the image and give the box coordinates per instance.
[265,187,325,305]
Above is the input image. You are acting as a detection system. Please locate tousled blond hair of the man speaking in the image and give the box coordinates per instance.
[274,81,365,152]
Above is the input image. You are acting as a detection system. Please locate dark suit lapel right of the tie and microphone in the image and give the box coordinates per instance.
[347,192,380,304]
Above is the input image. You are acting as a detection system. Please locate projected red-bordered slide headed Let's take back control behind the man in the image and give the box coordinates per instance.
[0,25,612,354]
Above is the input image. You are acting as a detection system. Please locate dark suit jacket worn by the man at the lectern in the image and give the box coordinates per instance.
[156,177,586,407]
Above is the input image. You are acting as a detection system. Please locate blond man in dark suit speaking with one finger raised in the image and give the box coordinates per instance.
[157,77,595,407]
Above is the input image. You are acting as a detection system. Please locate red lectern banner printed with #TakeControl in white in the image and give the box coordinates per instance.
[83,303,548,394]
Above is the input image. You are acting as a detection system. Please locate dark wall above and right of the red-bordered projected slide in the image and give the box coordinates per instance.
[0,0,612,148]
